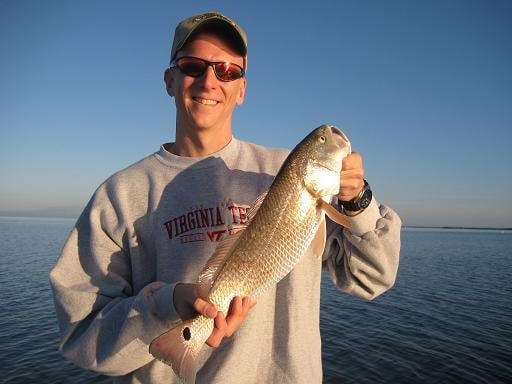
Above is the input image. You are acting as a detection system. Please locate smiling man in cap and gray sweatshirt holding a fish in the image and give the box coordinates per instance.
[50,13,400,384]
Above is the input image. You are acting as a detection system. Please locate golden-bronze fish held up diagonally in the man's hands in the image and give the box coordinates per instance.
[149,125,351,384]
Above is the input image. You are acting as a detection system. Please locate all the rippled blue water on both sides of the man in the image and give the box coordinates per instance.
[0,218,512,384]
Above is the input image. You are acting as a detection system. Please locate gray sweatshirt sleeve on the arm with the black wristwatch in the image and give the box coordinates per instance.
[323,199,401,300]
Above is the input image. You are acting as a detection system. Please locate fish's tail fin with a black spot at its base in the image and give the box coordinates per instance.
[149,316,213,384]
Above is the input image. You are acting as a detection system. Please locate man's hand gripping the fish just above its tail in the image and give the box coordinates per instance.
[173,283,256,348]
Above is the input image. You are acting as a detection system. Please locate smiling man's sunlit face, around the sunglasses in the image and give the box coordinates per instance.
[165,34,246,135]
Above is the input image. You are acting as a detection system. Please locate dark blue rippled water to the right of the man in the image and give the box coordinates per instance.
[322,230,512,383]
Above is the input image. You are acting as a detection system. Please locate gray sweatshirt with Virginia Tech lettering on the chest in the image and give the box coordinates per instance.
[50,138,401,384]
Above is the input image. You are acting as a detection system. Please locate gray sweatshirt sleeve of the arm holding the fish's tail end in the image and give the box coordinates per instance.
[50,183,178,376]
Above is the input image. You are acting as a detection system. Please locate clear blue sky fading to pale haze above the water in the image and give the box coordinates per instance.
[0,0,512,227]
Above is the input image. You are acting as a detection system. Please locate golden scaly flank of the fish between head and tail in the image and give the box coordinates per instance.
[209,178,322,313]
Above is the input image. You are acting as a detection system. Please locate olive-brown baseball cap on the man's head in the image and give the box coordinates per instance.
[171,12,247,62]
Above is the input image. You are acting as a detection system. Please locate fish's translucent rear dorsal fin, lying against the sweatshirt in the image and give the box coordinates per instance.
[197,229,244,299]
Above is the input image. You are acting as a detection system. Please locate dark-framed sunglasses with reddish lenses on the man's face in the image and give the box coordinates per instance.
[174,56,245,81]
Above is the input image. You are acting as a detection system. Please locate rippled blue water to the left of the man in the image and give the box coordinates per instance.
[0,217,111,384]
